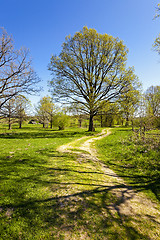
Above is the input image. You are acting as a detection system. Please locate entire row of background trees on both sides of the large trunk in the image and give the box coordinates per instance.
[0,86,160,132]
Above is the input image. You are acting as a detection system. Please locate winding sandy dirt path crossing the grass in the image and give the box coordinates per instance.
[58,130,160,240]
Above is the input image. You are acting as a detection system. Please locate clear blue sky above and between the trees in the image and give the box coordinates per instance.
[0,0,160,105]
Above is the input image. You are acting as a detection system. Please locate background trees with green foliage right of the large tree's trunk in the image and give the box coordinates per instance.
[99,86,160,130]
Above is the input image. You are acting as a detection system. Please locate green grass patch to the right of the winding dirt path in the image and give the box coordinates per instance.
[96,128,160,201]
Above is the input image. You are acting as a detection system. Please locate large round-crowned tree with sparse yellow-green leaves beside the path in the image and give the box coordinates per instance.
[49,27,138,131]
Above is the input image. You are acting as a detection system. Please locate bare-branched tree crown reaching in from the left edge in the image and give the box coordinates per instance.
[0,29,40,108]
